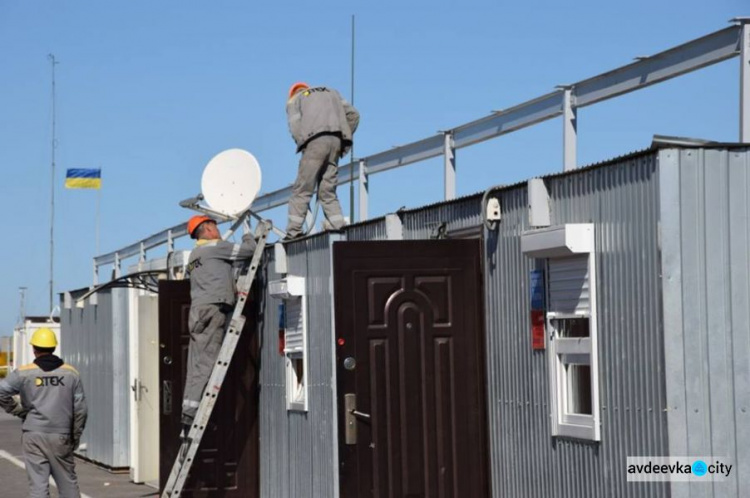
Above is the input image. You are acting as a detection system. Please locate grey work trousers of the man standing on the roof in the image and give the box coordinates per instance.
[286,135,344,238]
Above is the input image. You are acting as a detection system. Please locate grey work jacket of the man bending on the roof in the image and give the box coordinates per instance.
[286,86,359,155]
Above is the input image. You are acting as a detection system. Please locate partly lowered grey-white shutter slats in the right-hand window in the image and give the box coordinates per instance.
[548,254,591,315]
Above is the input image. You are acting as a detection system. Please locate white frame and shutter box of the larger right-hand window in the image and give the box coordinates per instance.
[521,223,601,441]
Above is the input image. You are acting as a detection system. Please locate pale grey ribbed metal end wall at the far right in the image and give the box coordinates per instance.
[660,148,750,497]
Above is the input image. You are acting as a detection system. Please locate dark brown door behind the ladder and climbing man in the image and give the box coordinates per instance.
[159,280,260,498]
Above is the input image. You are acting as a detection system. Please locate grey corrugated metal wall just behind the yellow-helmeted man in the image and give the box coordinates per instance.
[60,289,130,468]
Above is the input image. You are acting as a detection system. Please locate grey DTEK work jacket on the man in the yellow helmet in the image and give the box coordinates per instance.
[0,357,88,439]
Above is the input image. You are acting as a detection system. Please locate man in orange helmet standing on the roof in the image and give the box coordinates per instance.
[286,83,359,240]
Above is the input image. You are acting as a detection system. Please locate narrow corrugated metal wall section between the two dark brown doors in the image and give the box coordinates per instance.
[260,234,338,498]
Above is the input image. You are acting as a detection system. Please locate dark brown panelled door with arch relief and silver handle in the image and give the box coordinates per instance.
[333,240,489,498]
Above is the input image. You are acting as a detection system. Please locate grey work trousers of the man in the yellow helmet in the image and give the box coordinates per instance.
[23,431,81,498]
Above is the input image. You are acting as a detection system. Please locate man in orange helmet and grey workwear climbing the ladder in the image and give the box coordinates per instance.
[182,215,256,439]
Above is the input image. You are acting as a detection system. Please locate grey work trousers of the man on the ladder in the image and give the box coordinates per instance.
[182,304,232,424]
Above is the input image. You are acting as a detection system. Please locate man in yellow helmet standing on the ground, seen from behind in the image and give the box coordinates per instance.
[0,328,88,498]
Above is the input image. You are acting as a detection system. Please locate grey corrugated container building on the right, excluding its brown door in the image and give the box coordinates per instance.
[260,144,750,497]
